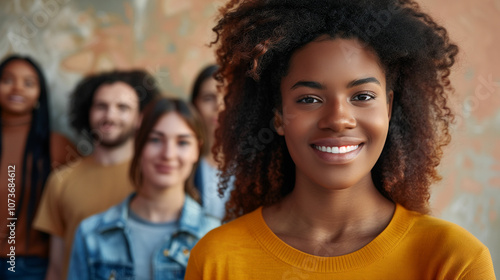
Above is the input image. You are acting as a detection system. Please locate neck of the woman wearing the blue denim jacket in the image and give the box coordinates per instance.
[130,186,186,223]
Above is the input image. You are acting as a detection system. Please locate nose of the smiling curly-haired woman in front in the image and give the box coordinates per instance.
[318,99,356,132]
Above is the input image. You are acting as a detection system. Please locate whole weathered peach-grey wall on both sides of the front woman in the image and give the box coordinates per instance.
[0,0,500,278]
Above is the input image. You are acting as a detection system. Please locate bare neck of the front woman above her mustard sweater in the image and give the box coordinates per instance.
[264,176,395,242]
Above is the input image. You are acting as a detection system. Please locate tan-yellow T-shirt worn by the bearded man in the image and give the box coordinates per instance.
[34,156,133,275]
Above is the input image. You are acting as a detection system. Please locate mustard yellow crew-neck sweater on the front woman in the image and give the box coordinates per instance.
[185,205,495,280]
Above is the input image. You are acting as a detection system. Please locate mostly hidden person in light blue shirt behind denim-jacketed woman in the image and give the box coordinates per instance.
[191,64,231,219]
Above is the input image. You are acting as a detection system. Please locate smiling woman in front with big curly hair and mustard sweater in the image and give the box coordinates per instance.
[186,0,495,279]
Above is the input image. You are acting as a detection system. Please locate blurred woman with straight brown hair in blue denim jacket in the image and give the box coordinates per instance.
[68,99,220,280]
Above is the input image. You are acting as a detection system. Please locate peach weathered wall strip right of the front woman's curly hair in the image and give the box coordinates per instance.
[420,0,500,278]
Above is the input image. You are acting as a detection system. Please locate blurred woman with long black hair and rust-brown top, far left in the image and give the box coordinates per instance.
[0,55,77,279]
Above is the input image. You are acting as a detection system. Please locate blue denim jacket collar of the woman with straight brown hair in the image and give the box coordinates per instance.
[97,193,205,239]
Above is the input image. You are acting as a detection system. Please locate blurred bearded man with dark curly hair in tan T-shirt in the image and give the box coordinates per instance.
[35,70,159,280]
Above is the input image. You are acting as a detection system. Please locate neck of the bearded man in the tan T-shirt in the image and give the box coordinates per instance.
[93,138,134,165]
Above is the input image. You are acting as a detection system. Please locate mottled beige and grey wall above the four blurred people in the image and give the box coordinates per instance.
[0,0,222,137]
